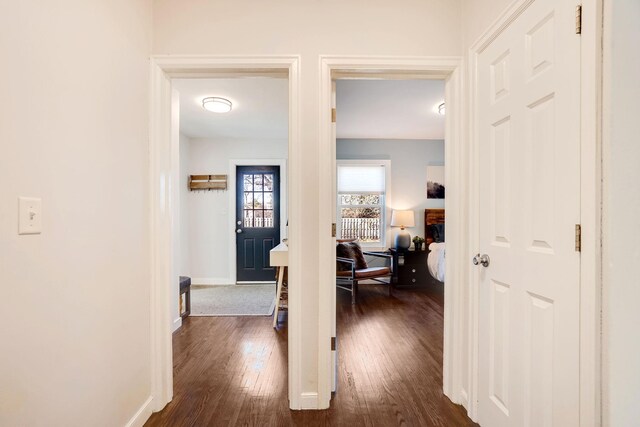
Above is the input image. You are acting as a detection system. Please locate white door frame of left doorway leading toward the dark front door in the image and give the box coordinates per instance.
[148,55,303,412]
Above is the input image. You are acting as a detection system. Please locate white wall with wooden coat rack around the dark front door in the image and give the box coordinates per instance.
[180,138,288,284]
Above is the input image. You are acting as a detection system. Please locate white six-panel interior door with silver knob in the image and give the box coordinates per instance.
[477,0,580,427]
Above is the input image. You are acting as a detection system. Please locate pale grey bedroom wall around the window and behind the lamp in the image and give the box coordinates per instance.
[336,139,444,244]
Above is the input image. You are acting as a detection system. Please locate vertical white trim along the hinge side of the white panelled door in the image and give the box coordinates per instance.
[580,0,603,427]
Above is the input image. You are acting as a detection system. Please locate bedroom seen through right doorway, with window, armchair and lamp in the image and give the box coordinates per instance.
[333,78,456,418]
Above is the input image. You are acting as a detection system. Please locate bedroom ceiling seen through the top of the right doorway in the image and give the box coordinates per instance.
[336,80,444,139]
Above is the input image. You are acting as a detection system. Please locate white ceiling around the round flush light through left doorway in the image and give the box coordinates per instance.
[173,77,289,139]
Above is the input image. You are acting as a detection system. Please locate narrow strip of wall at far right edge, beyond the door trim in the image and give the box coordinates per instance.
[602,0,640,427]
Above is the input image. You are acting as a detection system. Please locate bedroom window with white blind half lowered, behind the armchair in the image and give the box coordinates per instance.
[337,162,386,245]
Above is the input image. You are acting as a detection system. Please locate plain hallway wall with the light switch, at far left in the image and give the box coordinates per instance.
[0,0,151,426]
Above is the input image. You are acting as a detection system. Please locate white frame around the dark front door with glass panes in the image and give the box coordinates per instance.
[227,159,288,285]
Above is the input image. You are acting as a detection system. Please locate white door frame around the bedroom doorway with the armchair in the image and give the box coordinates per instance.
[318,55,470,408]
